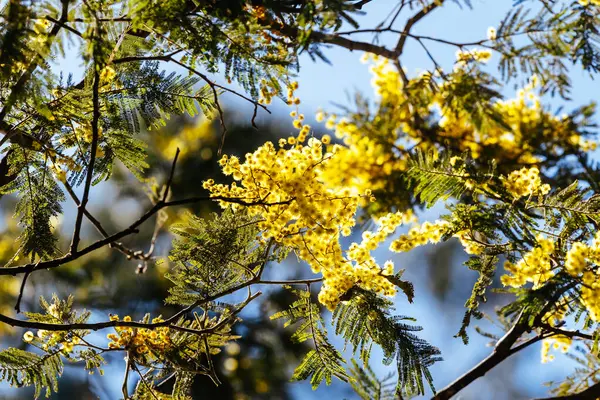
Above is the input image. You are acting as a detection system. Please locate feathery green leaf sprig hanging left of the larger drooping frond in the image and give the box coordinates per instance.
[271,288,349,389]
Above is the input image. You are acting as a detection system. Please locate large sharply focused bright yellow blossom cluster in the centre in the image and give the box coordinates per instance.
[203,129,422,309]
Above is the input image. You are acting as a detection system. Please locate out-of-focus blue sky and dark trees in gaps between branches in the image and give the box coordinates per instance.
[0,0,600,400]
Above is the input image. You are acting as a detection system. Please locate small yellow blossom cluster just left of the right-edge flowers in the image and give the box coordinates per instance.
[501,236,554,288]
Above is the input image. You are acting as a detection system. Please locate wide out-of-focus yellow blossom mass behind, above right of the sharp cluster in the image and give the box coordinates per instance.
[314,55,596,219]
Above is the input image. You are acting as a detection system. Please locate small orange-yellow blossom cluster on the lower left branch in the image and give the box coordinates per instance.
[107,315,172,357]
